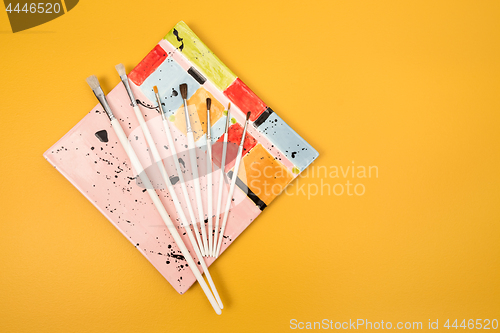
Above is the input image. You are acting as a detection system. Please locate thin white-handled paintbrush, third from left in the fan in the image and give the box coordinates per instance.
[153,86,206,256]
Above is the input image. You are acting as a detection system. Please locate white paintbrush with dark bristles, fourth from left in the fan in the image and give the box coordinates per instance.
[179,83,208,253]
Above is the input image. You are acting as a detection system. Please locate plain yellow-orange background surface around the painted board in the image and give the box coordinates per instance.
[0,0,500,332]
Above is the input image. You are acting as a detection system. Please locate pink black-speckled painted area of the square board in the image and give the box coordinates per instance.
[44,84,260,294]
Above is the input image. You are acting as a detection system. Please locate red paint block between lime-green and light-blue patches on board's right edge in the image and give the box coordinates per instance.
[224,78,267,121]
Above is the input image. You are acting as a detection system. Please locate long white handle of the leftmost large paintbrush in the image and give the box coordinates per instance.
[111,118,222,314]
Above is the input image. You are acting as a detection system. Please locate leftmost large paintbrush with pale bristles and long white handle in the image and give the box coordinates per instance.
[87,75,221,314]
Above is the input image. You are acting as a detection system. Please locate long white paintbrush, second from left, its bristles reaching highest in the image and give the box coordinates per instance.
[115,64,223,309]
